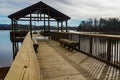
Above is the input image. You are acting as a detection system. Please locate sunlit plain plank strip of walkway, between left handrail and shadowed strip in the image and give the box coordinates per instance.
[37,40,87,80]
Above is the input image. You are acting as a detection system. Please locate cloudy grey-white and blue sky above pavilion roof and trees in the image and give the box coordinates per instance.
[0,0,120,25]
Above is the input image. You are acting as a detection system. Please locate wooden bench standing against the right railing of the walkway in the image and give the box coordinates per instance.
[60,39,79,51]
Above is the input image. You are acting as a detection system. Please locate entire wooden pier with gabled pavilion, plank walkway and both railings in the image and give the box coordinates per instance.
[5,2,120,80]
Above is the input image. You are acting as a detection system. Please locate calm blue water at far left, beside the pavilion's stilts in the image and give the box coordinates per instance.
[0,30,13,67]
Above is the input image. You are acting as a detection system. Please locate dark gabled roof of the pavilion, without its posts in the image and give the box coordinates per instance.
[8,1,70,21]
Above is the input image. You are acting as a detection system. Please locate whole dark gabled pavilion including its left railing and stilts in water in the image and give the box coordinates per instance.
[8,1,70,57]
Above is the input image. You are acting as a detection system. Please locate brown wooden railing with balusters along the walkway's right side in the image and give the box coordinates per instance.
[51,32,120,69]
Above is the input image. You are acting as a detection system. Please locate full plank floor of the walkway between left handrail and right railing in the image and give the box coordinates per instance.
[37,39,120,80]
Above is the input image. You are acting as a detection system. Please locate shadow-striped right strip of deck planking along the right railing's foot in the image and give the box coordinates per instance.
[47,40,120,80]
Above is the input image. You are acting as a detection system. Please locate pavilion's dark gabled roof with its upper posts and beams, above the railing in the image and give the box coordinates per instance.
[8,1,70,38]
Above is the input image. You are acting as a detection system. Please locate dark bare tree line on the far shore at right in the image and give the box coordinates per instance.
[77,18,120,32]
